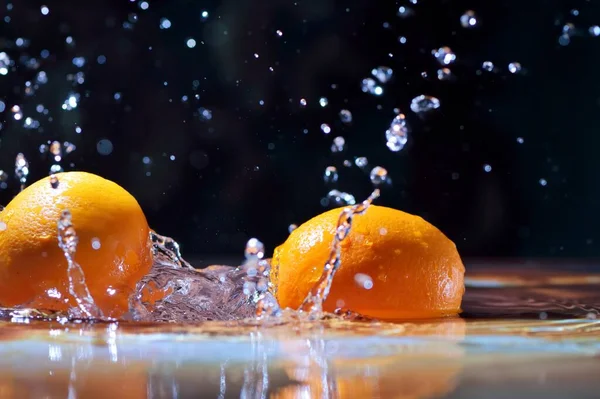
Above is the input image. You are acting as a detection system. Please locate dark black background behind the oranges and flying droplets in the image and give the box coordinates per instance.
[0,0,600,257]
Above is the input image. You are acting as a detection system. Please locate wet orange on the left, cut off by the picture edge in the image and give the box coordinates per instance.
[0,172,153,317]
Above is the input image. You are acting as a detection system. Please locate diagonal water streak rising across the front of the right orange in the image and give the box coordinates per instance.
[298,189,380,318]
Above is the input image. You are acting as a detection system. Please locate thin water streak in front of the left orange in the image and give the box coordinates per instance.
[58,210,103,319]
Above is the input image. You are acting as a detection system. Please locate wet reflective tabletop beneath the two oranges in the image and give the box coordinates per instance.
[0,262,600,398]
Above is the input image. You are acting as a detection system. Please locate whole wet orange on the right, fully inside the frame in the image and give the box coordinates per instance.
[271,205,465,320]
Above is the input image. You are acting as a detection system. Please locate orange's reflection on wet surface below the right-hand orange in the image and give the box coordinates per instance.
[271,319,465,399]
